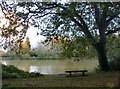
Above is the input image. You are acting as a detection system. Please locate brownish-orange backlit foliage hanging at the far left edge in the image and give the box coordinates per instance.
[0,3,28,54]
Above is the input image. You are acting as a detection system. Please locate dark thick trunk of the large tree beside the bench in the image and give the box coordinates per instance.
[95,42,110,71]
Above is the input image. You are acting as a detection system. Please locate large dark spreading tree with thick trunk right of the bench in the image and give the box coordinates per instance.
[3,2,120,71]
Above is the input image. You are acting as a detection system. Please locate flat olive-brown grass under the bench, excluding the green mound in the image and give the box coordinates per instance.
[2,72,119,88]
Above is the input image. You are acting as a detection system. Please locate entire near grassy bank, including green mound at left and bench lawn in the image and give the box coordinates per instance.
[2,65,120,89]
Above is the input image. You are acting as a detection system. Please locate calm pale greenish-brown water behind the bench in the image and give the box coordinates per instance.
[2,58,98,74]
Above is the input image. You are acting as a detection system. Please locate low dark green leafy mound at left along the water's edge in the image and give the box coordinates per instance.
[2,65,41,79]
